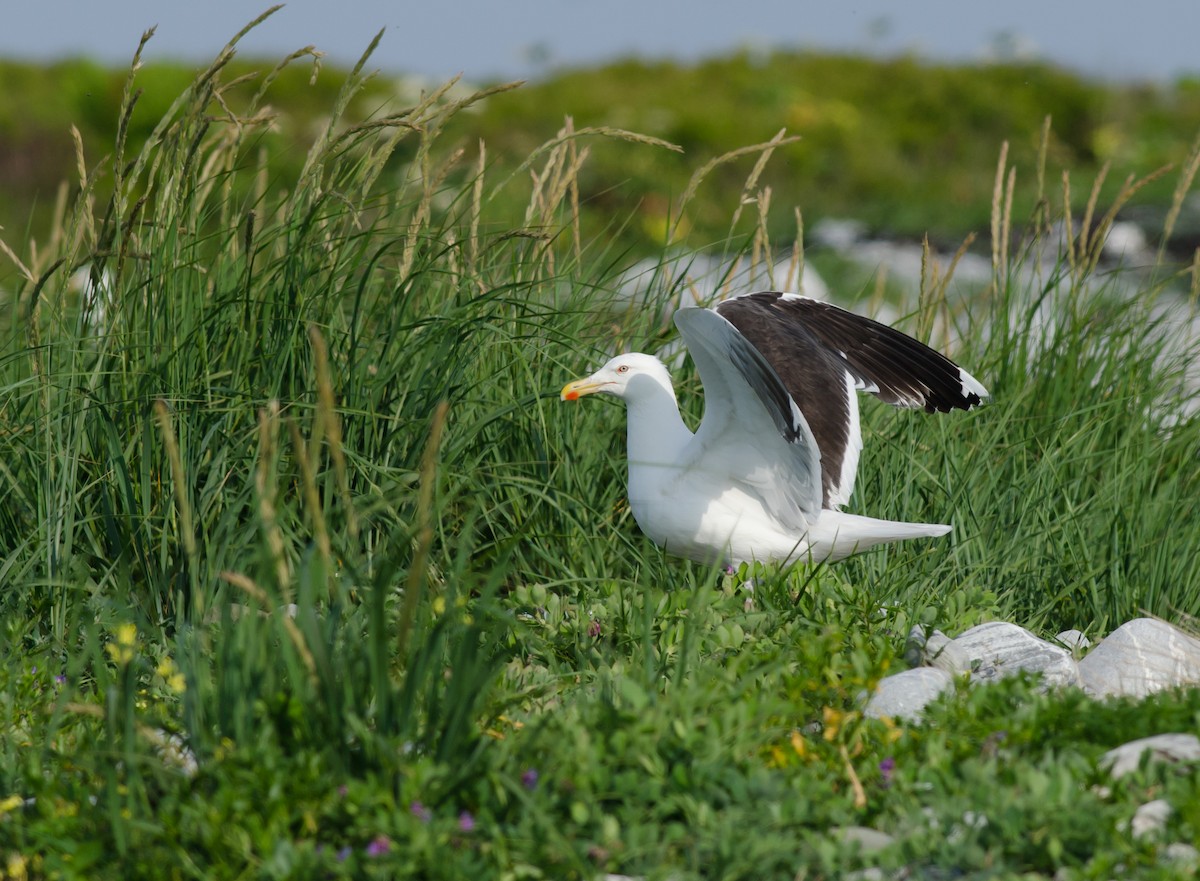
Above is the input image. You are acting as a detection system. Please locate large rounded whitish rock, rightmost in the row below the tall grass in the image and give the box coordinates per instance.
[1079,618,1200,697]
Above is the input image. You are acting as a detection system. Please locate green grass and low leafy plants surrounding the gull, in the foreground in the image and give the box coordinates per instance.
[0,15,1200,879]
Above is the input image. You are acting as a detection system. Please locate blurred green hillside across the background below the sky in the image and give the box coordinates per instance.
[7,47,1200,261]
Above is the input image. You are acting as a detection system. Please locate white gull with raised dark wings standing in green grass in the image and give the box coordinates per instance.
[560,290,989,568]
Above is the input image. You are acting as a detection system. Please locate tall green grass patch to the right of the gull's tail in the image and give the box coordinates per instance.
[851,134,1200,635]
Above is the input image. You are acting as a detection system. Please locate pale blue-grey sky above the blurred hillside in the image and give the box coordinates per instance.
[0,0,1200,80]
